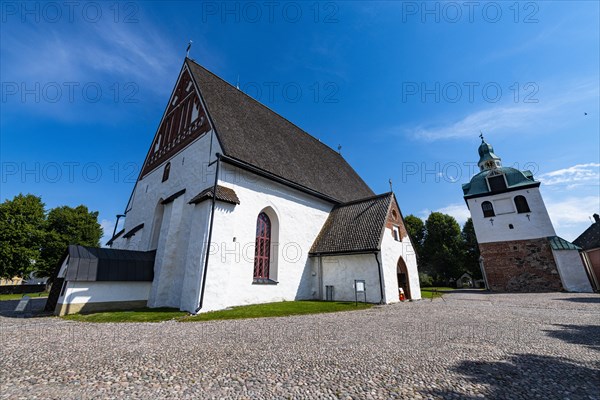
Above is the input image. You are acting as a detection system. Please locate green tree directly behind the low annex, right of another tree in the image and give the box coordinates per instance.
[38,205,103,276]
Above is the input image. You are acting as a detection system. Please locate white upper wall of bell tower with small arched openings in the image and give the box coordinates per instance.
[467,188,556,243]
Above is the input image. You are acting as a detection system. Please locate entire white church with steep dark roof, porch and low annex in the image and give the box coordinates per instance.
[47,58,420,315]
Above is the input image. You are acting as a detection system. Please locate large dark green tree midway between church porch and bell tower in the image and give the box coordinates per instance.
[422,212,462,283]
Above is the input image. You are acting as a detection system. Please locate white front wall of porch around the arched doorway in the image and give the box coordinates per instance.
[381,228,421,303]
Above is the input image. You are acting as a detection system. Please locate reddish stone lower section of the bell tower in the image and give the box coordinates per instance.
[479,238,563,292]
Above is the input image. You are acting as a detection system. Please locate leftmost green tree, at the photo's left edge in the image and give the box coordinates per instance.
[0,194,44,278]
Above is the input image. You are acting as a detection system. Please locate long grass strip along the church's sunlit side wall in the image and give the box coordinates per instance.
[181,300,373,322]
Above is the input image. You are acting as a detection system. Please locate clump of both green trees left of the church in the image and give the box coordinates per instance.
[0,194,103,278]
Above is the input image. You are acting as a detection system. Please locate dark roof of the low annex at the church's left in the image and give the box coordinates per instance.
[65,245,156,282]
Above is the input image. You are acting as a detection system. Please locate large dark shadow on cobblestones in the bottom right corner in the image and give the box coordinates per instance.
[424,354,600,399]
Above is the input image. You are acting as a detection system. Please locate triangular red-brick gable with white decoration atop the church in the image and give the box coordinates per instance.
[140,66,211,178]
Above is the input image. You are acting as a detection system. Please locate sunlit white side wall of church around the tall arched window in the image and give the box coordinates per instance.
[199,163,333,312]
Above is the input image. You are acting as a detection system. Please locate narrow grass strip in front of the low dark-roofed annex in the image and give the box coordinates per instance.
[61,308,187,322]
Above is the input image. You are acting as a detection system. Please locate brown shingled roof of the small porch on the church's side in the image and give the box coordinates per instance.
[310,193,394,255]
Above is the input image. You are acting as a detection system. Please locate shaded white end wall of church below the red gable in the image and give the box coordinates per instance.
[112,126,220,311]
